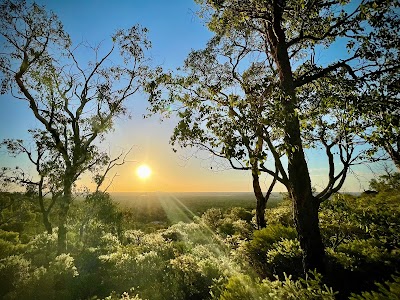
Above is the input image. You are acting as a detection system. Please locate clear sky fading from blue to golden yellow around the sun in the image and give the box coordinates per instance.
[0,0,388,192]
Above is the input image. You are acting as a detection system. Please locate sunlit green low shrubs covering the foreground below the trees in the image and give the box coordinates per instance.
[0,174,400,299]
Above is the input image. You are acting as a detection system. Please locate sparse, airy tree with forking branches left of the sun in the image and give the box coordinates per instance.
[0,0,150,252]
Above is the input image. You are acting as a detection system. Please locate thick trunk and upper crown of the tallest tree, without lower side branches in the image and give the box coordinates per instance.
[194,0,398,271]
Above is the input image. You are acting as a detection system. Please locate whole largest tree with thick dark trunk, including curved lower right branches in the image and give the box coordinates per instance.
[150,0,399,272]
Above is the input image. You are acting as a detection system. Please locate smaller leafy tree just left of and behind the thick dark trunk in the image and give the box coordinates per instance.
[149,35,284,229]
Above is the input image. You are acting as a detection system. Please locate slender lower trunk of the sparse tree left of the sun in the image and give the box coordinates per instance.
[57,179,72,254]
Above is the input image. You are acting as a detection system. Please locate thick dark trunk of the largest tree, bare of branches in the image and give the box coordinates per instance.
[265,0,325,273]
